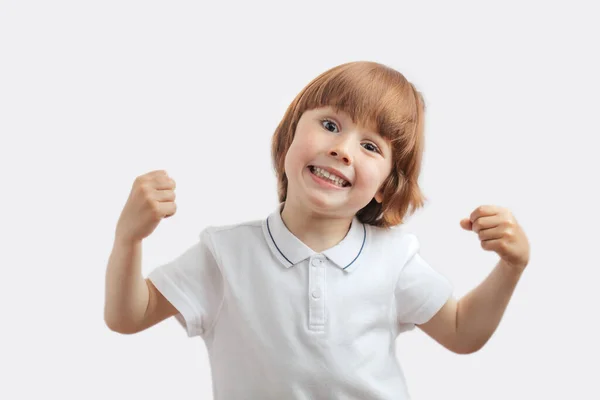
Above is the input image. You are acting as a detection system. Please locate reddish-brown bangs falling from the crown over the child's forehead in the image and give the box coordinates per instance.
[298,62,418,142]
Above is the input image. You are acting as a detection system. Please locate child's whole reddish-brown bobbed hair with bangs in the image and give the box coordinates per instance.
[271,61,427,228]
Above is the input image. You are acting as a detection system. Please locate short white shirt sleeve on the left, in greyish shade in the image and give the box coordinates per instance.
[148,229,223,337]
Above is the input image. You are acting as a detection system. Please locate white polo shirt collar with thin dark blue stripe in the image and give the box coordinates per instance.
[262,203,368,272]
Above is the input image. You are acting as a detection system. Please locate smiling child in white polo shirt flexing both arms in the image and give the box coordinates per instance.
[105,62,529,399]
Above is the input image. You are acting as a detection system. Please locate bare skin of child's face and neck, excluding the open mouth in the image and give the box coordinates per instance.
[281,107,392,252]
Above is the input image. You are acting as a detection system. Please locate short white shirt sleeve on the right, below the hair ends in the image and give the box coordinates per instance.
[395,234,453,331]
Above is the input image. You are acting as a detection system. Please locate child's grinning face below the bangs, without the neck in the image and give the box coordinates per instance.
[285,107,392,216]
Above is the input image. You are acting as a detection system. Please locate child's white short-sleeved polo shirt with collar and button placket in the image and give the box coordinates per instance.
[149,203,452,400]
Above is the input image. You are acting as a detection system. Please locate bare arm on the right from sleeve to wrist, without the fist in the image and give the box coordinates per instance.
[418,259,522,354]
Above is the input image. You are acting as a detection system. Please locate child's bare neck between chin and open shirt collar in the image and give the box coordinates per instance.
[281,202,352,253]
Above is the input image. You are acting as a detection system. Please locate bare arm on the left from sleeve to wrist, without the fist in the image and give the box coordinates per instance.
[104,240,178,334]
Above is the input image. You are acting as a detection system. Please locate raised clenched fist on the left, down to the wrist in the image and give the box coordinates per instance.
[115,170,177,242]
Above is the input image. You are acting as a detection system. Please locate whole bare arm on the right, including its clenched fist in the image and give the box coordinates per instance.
[418,206,530,354]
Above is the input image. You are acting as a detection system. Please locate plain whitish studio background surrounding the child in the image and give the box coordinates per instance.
[0,1,600,400]
